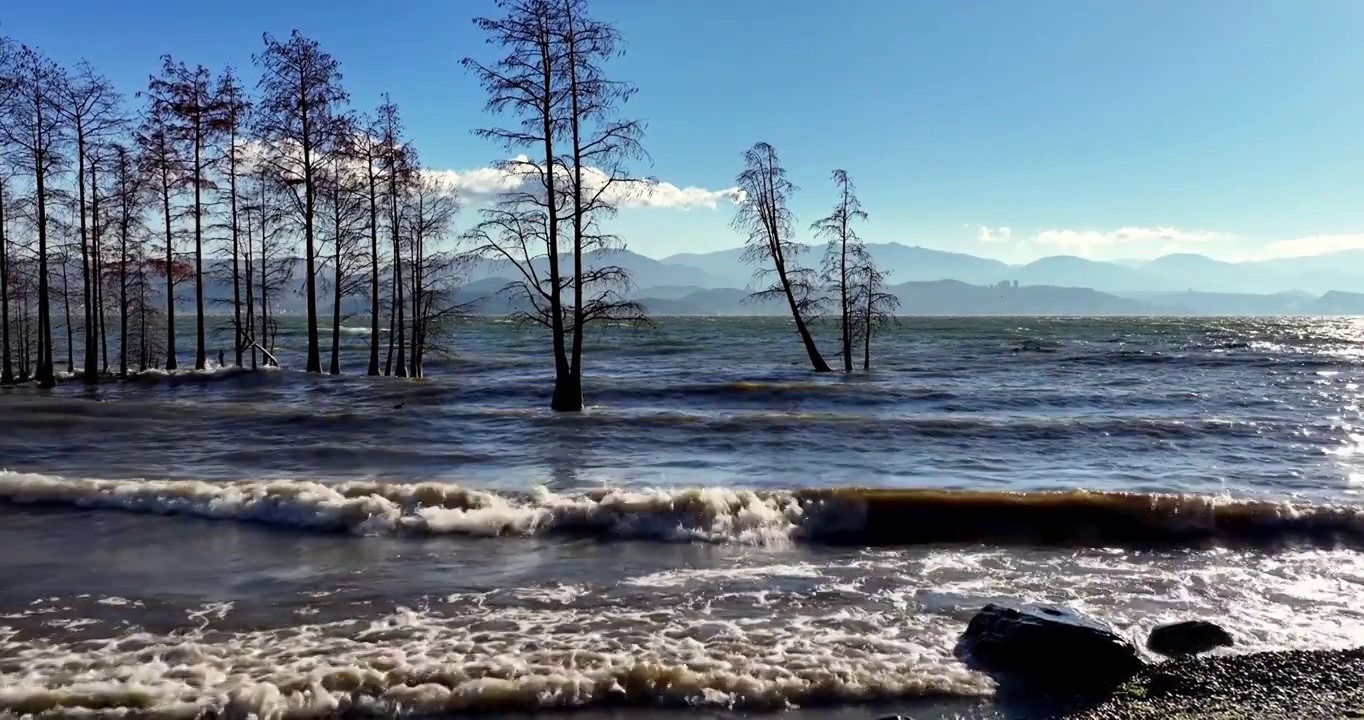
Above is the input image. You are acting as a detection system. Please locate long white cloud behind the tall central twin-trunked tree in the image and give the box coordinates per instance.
[432,155,743,210]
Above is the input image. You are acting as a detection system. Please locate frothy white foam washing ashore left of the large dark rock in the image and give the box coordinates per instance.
[0,596,992,719]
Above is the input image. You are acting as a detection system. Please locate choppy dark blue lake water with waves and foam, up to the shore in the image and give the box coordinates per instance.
[0,319,1364,717]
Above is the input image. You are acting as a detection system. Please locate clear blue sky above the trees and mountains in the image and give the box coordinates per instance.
[0,0,1364,260]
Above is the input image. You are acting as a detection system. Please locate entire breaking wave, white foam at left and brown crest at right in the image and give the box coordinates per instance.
[0,472,1364,548]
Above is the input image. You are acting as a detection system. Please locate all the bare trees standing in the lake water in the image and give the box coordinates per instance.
[0,0,916,412]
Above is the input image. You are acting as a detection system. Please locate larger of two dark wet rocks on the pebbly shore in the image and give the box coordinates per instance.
[956,603,1146,695]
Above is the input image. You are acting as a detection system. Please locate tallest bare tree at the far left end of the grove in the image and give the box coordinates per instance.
[0,46,68,387]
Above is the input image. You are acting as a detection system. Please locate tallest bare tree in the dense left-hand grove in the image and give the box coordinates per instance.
[255,30,348,372]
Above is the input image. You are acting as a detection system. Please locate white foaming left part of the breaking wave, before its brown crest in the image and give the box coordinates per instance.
[0,472,805,544]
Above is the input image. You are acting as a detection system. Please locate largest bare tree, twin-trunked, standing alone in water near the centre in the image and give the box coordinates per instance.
[464,0,644,410]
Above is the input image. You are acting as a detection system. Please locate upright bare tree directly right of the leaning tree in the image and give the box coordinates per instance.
[810,170,868,372]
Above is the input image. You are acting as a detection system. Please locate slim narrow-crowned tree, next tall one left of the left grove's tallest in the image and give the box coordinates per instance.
[213,67,251,367]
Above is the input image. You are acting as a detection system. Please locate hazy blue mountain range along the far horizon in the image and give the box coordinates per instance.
[195,243,1364,315]
